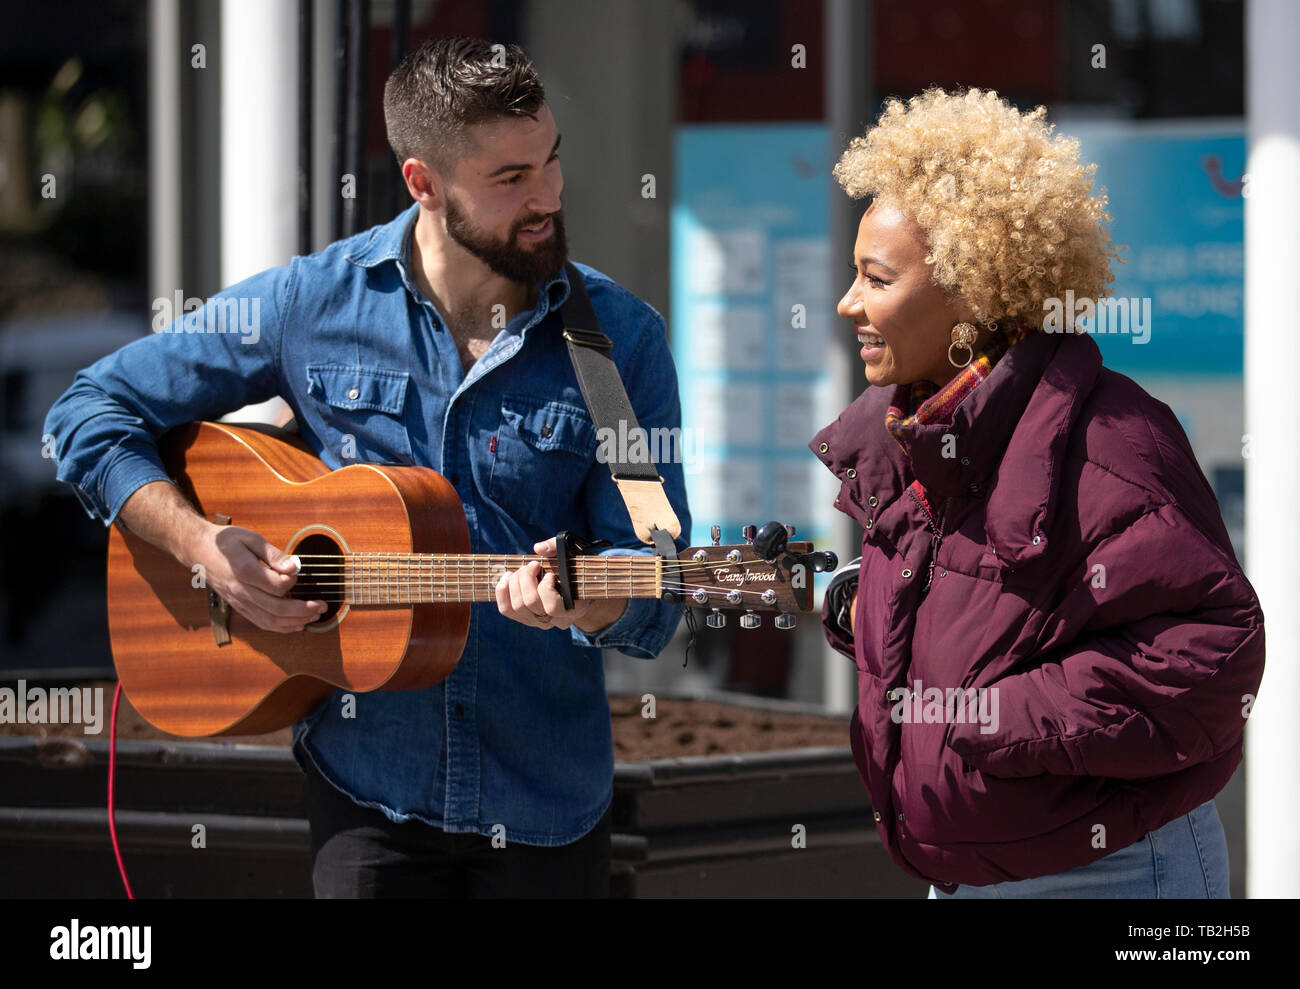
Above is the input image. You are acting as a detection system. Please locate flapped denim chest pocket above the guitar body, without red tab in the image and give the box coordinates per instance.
[307,364,415,464]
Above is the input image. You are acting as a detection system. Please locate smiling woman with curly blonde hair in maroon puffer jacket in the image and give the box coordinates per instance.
[810,90,1264,898]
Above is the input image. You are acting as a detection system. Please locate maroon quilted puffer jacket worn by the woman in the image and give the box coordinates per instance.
[810,333,1264,893]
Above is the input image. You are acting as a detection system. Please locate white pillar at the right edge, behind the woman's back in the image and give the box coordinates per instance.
[1244,0,1300,898]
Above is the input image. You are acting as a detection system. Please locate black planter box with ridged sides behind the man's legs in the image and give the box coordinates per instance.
[0,698,927,898]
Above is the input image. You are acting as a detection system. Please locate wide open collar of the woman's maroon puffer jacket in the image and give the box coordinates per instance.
[810,331,1101,569]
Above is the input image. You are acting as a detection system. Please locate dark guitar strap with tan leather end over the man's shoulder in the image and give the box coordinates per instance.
[560,263,681,543]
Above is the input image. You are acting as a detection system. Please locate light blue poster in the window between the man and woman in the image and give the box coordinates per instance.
[672,123,840,543]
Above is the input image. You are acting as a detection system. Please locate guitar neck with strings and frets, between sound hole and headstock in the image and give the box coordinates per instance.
[304,552,663,604]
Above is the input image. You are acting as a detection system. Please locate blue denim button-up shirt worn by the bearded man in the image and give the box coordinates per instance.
[46,205,690,845]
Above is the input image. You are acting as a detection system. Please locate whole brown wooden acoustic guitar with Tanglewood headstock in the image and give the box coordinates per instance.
[108,422,835,737]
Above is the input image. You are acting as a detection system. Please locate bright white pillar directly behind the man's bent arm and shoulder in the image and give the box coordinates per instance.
[220,0,298,421]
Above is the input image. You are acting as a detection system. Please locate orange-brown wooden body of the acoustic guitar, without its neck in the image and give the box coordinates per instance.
[108,422,469,737]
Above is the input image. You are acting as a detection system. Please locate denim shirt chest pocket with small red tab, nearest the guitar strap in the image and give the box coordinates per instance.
[488,394,597,534]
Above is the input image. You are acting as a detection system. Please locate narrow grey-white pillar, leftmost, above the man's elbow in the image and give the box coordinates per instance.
[150,0,180,309]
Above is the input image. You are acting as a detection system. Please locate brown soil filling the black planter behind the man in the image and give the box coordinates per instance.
[0,680,849,763]
